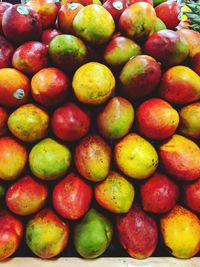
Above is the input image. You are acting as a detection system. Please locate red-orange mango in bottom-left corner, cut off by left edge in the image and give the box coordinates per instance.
[0,212,23,261]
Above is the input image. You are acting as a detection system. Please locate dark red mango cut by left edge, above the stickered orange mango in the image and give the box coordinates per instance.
[0,35,14,69]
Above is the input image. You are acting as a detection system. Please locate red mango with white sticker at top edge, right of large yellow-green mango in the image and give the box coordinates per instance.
[103,0,128,22]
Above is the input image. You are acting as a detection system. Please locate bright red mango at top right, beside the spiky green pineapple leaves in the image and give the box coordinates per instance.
[155,1,181,30]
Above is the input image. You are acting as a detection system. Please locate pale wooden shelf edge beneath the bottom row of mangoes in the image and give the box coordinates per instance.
[0,257,200,267]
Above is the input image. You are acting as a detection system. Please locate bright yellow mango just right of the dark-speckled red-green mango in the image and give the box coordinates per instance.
[114,133,158,179]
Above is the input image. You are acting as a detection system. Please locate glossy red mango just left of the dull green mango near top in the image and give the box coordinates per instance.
[12,41,48,75]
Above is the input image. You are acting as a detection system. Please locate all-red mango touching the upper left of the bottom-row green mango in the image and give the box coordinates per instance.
[53,173,92,220]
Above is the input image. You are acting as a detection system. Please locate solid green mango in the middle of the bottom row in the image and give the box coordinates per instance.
[74,209,113,259]
